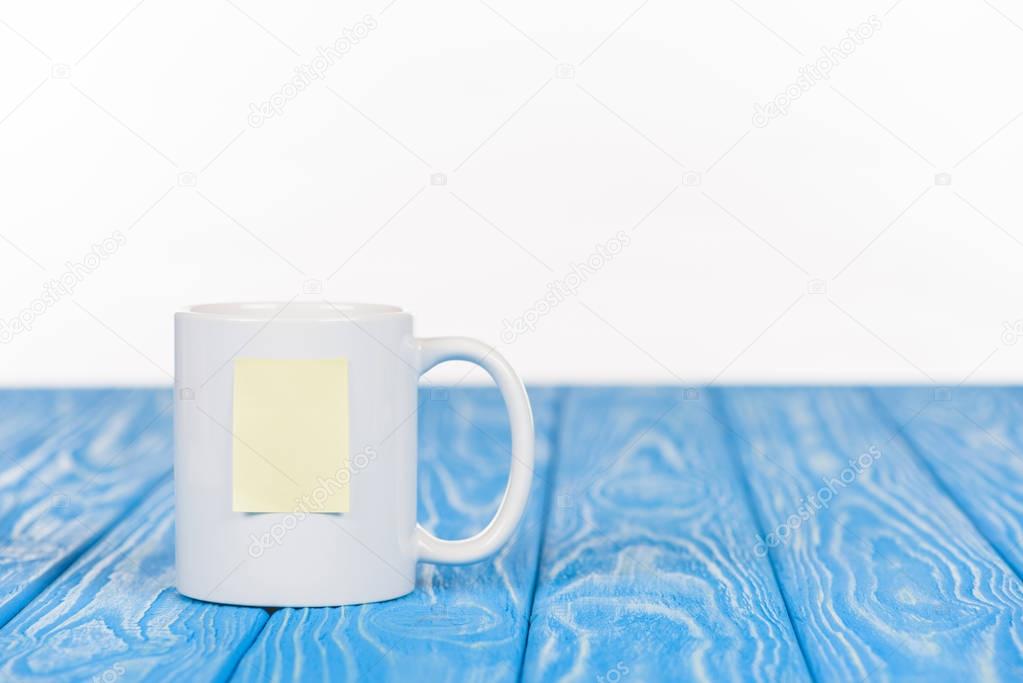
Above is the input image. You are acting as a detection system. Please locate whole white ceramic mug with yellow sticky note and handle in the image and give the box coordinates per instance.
[174,303,534,606]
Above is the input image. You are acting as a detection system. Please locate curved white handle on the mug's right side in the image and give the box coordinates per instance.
[415,336,534,564]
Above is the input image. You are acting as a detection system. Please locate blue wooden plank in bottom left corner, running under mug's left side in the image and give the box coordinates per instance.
[0,476,267,682]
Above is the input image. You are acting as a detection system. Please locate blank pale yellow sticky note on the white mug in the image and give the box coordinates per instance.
[231,358,349,512]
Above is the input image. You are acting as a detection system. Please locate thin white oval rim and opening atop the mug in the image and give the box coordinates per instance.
[177,300,404,322]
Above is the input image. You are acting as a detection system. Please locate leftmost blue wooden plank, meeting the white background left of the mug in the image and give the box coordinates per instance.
[0,390,172,625]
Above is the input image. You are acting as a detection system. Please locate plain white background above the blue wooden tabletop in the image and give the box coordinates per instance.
[0,0,1023,384]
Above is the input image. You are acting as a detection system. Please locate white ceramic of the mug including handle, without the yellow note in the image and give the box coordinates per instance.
[174,303,533,606]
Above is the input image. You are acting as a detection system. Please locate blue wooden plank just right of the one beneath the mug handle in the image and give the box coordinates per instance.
[524,389,808,681]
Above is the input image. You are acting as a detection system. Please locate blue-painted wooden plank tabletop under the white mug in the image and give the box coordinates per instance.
[0,388,1023,683]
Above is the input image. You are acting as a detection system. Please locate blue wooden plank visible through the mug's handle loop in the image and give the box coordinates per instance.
[235,389,558,683]
